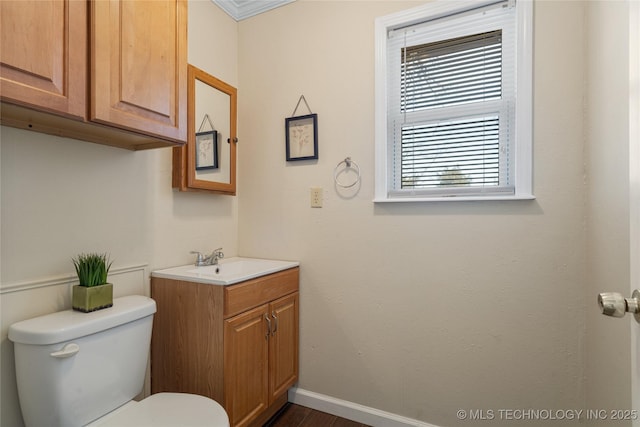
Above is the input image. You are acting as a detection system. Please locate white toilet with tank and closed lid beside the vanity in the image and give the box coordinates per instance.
[9,295,229,427]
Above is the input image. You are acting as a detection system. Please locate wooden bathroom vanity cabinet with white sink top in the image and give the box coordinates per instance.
[151,258,299,427]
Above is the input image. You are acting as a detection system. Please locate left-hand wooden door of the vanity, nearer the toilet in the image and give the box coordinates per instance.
[224,304,270,427]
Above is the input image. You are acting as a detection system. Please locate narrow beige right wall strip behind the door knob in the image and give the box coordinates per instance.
[585,2,637,425]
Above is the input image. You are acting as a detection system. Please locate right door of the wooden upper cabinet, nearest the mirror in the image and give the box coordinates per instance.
[90,0,187,142]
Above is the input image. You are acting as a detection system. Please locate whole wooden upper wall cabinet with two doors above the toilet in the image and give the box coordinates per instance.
[0,0,187,149]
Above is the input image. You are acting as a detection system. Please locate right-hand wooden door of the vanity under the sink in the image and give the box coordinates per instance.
[269,292,298,402]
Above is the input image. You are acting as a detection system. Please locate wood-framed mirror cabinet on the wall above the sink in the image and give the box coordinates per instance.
[172,64,238,195]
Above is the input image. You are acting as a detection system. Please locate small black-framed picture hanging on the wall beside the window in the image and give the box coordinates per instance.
[285,114,318,161]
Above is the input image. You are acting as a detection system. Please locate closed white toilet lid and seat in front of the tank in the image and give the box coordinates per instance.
[88,393,229,427]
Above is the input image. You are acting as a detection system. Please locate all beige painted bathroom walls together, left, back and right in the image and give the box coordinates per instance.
[0,0,630,427]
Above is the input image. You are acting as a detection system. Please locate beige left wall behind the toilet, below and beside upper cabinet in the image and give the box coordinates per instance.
[0,1,238,427]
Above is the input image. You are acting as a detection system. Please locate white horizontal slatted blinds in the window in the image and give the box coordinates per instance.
[387,3,515,196]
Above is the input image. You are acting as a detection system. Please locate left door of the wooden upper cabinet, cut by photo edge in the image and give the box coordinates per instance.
[0,0,87,119]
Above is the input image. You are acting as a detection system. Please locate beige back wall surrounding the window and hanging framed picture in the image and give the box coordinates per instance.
[239,0,587,426]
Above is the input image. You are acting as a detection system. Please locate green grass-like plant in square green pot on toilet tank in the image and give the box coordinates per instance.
[71,253,113,313]
